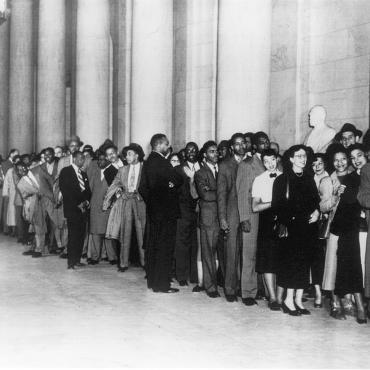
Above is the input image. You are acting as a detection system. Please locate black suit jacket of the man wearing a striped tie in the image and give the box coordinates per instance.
[59,165,91,219]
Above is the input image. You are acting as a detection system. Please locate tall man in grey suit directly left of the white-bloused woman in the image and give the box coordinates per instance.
[236,131,270,306]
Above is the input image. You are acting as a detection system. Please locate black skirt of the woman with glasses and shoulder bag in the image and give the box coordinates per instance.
[277,219,317,289]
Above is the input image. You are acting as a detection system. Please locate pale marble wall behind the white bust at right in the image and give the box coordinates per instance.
[270,0,370,149]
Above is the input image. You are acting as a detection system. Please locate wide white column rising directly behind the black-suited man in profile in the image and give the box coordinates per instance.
[131,0,173,152]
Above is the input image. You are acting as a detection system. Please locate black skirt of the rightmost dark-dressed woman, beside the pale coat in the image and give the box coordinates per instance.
[334,230,363,296]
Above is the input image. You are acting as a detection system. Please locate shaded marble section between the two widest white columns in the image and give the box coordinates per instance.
[174,0,218,149]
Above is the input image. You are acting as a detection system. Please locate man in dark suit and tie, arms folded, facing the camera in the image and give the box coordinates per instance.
[194,141,220,298]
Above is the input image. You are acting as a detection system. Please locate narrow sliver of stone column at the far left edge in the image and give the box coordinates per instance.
[0,21,10,158]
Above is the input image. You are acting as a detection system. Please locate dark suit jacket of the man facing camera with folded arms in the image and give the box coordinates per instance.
[194,165,218,227]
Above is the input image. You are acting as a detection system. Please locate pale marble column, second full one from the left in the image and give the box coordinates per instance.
[36,0,66,150]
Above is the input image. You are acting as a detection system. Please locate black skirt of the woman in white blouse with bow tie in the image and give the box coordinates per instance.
[256,209,279,274]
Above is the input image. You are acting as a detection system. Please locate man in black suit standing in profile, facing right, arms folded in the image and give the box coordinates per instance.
[139,134,183,293]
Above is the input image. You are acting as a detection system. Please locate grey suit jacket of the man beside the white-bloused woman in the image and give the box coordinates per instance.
[236,154,265,222]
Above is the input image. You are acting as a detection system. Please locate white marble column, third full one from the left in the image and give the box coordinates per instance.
[76,0,110,147]
